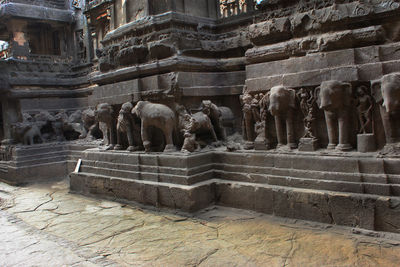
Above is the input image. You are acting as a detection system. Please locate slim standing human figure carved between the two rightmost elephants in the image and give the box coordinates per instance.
[356,86,374,134]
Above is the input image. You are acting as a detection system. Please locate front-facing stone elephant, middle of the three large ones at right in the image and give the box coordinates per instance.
[315,80,352,151]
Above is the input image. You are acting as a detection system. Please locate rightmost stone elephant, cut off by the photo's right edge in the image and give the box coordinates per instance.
[371,73,400,144]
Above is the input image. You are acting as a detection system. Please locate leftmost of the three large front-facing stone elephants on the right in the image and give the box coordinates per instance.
[266,86,297,149]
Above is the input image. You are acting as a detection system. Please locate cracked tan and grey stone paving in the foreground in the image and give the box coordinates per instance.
[0,181,400,267]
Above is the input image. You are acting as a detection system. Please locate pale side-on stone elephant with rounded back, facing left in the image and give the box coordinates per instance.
[132,101,176,152]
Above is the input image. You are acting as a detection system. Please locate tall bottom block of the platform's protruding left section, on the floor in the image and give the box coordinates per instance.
[70,172,215,212]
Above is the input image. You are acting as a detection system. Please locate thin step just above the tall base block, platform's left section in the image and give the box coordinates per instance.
[80,165,213,185]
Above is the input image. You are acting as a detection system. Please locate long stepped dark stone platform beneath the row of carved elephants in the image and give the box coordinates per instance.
[70,149,400,236]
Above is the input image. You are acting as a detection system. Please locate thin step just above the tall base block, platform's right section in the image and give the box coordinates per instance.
[214,170,391,196]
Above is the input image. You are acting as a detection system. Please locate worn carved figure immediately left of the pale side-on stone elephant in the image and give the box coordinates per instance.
[114,102,140,151]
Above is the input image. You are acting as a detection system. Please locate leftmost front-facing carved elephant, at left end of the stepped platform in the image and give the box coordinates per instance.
[95,103,116,150]
